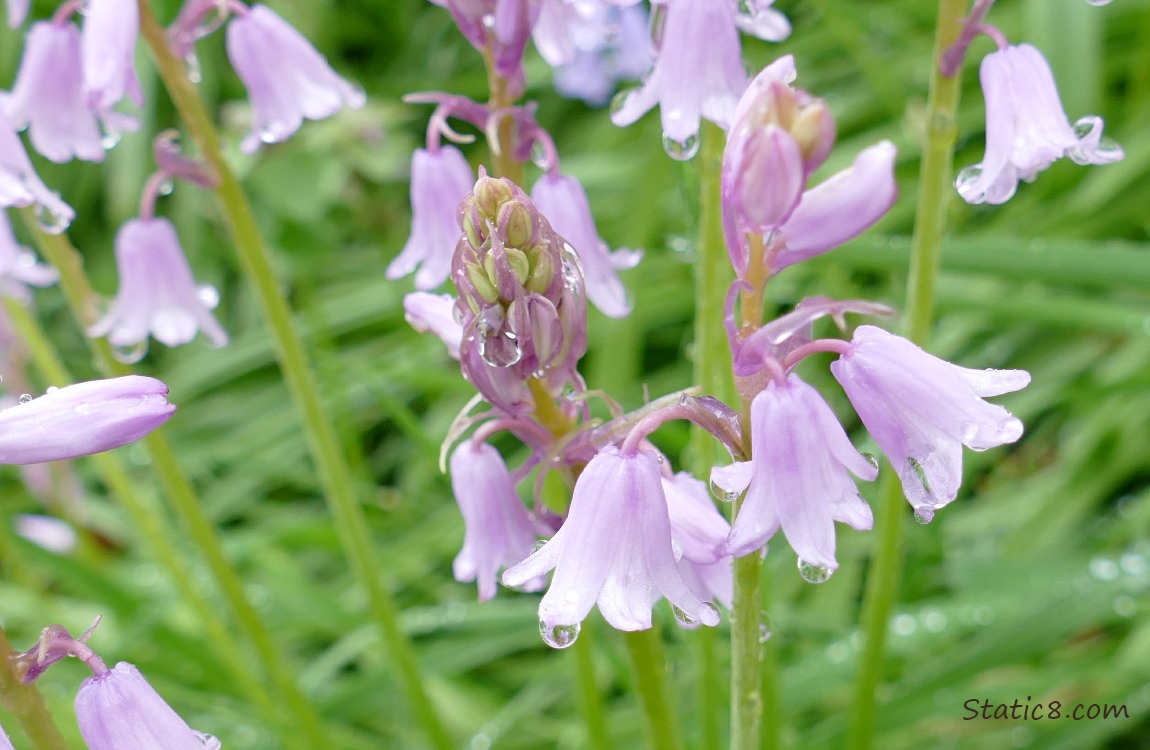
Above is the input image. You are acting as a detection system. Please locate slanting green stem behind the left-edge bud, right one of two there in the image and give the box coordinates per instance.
[24,212,327,748]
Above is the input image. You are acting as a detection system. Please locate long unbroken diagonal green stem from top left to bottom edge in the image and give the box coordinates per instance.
[139,0,453,750]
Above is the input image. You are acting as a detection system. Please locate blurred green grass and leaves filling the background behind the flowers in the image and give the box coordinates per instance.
[0,0,1150,750]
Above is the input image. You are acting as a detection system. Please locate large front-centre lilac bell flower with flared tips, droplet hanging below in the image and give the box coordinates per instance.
[503,446,719,633]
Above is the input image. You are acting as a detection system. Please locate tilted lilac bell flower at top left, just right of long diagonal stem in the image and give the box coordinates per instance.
[227,5,366,153]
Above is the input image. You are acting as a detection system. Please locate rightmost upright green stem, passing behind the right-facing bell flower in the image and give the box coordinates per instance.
[846,0,966,750]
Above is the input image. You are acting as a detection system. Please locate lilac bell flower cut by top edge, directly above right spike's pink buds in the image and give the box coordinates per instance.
[611,0,746,144]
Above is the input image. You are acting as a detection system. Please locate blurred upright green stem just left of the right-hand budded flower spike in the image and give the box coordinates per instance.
[688,122,738,748]
